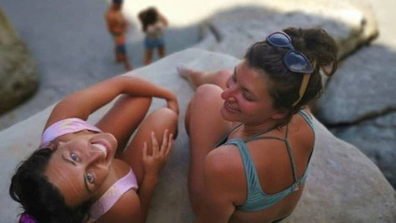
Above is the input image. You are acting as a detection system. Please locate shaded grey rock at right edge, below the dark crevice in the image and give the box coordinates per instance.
[331,112,396,188]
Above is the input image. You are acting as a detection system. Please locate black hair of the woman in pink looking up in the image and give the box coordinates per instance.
[9,148,91,223]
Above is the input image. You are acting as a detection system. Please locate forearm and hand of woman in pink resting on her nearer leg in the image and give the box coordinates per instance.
[138,130,173,222]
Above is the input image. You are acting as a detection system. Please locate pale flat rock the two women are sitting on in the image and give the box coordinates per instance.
[0,49,396,223]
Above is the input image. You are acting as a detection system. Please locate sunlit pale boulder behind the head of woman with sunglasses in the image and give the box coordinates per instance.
[197,0,378,58]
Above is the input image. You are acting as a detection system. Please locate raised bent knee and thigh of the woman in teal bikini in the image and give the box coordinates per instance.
[185,84,232,213]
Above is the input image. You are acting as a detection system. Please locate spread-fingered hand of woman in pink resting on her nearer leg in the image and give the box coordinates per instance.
[143,129,173,178]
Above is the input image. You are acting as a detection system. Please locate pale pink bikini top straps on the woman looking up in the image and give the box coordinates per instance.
[41,118,139,223]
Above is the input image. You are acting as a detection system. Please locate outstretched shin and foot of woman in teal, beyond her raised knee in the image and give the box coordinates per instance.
[177,67,232,90]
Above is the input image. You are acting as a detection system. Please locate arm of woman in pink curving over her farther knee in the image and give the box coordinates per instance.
[44,76,178,129]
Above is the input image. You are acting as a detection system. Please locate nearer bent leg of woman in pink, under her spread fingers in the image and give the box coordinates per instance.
[122,107,177,184]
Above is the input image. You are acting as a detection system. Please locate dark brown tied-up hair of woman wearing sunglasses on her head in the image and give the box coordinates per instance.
[244,28,338,127]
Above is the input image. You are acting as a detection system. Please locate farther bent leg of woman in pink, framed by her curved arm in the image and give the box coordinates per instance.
[96,96,151,158]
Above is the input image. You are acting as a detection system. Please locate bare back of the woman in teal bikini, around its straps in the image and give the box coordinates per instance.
[212,110,314,222]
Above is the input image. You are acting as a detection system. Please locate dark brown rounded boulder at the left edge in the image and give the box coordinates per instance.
[0,8,38,114]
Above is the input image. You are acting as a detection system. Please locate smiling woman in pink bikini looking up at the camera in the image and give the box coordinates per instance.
[9,73,178,223]
